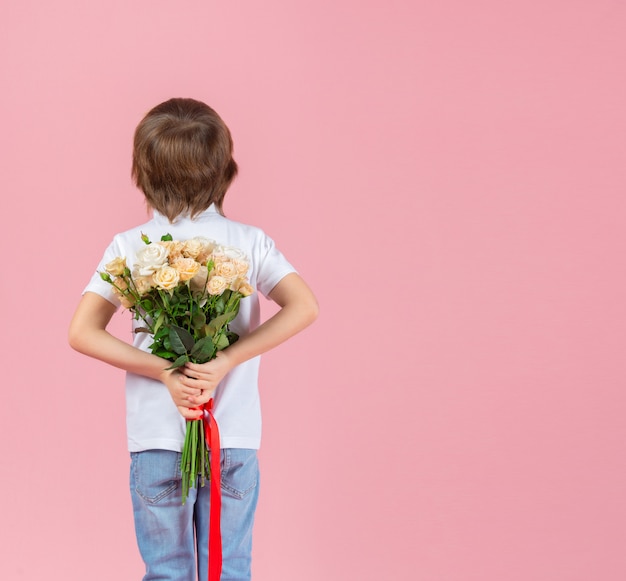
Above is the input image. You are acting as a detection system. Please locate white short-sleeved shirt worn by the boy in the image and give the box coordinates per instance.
[84,206,295,452]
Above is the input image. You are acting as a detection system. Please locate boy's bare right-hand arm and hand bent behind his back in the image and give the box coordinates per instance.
[180,273,319,404]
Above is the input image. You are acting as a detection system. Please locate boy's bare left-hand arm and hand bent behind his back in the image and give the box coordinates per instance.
[69,292,210,419]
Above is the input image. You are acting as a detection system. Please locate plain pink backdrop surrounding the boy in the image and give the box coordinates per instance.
[0,0,626,581]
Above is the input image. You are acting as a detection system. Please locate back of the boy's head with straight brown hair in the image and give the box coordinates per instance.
[132,99,237,222]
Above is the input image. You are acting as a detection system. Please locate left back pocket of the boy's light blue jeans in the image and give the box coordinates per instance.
[131,450,181,504]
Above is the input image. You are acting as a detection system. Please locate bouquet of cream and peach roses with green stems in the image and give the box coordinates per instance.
[100,234,253,504]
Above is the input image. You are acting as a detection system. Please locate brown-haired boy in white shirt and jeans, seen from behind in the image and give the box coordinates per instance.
[69,99,318,581]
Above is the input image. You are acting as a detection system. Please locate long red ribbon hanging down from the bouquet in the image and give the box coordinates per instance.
[203,399,222,581]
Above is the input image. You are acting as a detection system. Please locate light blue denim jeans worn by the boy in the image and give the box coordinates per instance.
[130,448,259,581]
